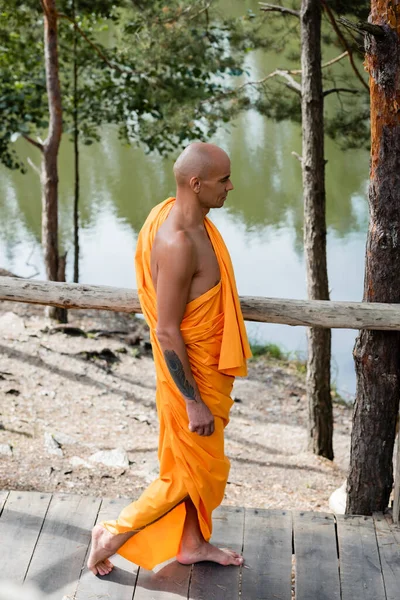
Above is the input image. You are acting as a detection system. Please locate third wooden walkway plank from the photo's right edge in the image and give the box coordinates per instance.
[293,512,340,600]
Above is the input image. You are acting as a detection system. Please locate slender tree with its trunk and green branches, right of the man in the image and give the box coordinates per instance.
[255,0,368,460]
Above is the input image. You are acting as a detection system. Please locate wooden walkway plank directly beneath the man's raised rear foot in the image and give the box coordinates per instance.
[74,498,138,600]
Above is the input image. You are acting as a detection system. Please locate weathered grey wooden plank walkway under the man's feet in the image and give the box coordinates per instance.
[0,491,400,600]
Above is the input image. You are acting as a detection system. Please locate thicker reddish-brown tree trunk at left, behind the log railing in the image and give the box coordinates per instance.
[41,0,62,318]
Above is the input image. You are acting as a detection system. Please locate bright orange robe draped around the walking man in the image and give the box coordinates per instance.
[103,198,251,569]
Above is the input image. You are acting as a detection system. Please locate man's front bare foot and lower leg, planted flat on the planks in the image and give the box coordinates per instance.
[176,500,243,566]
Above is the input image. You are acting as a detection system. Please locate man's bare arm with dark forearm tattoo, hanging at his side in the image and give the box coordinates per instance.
[156,232,214,435]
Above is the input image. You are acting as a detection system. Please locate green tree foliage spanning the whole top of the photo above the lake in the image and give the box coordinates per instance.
[0,0,369,170]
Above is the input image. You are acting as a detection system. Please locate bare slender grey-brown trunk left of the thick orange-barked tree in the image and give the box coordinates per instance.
[300,0,333,460]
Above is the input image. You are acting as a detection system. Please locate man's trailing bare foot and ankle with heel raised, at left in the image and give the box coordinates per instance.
[87,524,136,575]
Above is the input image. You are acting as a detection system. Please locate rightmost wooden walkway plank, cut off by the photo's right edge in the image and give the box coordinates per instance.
[373,513,400,600]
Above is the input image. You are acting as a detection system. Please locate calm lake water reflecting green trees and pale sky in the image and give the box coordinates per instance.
[0,2,369,398]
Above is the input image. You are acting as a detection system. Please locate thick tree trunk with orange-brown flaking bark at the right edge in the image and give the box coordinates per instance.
[346,0,400,515]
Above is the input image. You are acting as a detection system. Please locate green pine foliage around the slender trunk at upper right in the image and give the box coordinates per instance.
[251,0,370,149]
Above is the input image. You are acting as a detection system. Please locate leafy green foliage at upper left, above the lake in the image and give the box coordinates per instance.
[0,0,269,169]
